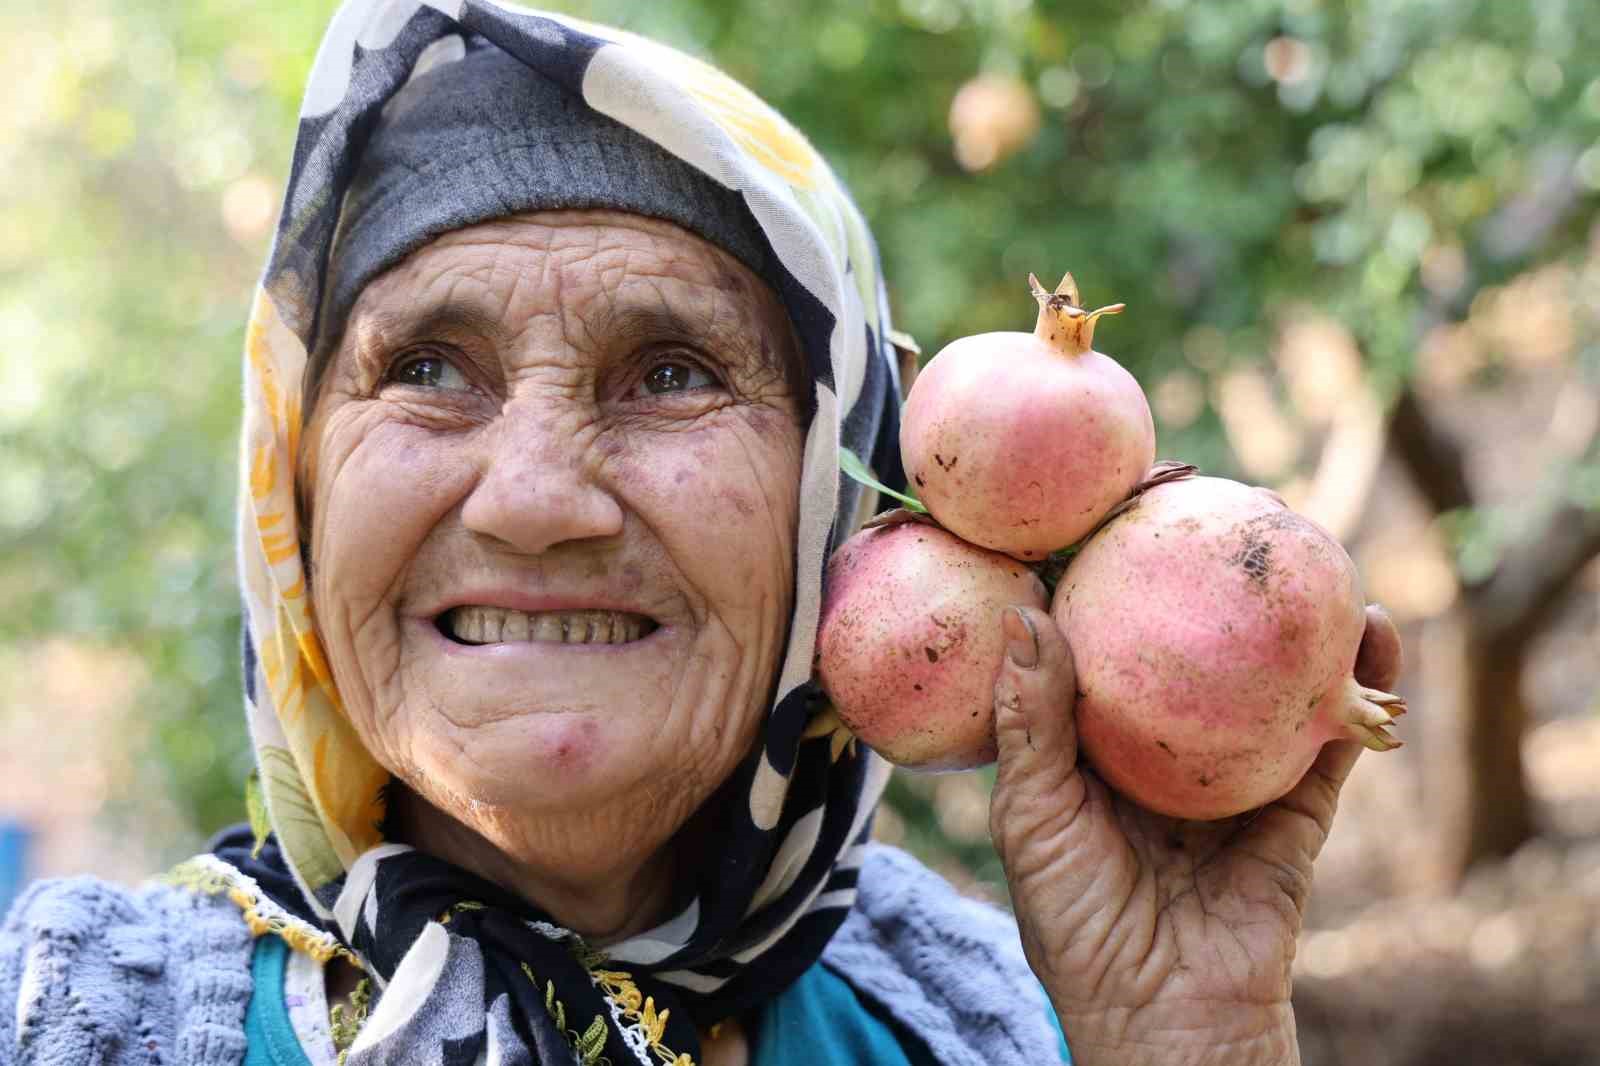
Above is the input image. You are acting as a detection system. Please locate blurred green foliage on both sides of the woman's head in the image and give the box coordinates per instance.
[0,0,1600,861]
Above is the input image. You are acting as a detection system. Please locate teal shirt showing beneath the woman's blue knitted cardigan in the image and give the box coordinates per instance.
[243,936,1072,1066]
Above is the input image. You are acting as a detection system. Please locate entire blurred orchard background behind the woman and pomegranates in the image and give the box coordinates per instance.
[0,0,1600,1066]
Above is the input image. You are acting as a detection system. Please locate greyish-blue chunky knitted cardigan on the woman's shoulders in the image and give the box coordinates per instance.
[0,845,1061,1066]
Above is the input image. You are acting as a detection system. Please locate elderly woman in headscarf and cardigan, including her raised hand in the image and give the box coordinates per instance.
[0,0,1398,1066]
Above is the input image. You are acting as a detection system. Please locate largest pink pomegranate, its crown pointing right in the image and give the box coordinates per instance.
[1051,477,1405,820]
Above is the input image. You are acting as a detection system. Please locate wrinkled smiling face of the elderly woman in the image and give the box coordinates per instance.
[302,211,802,870]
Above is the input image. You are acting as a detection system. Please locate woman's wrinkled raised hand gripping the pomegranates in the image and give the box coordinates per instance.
[989,607,1400,1066]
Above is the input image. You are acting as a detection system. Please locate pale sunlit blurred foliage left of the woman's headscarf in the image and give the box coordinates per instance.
[0,0,331,855]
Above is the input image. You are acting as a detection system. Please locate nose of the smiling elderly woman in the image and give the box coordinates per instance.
[461,405,622,555]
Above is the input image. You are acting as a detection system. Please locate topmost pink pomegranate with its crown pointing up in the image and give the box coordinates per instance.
[901,274,1155,559]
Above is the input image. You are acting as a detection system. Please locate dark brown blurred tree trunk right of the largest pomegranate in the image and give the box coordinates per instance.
[1456,627,1534,869]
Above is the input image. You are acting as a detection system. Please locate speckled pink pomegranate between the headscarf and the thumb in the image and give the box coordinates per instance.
[816,522,1048,770]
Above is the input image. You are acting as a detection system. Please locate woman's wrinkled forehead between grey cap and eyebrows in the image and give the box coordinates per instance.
[349,211,789,347]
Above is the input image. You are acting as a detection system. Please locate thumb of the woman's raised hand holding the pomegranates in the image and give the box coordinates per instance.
[994,607,1078,794]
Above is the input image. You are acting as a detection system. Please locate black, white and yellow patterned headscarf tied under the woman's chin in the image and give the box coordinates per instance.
[174,0,901,1066]
